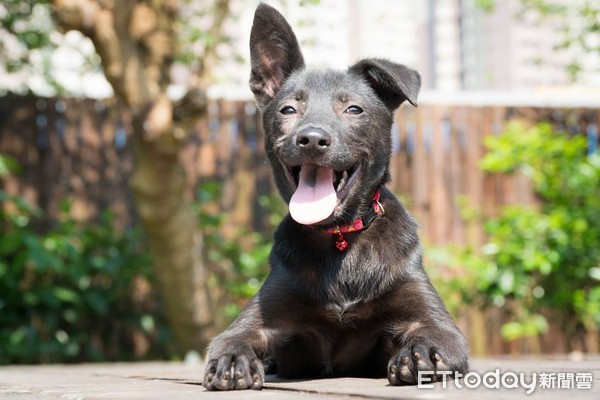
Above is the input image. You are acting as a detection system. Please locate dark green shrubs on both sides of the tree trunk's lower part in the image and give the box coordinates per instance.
[0,155,286,364]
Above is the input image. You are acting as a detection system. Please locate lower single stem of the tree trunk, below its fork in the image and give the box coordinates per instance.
[130,114,216,352]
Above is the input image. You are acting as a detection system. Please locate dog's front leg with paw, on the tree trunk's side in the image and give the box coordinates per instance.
[203,297,267,390]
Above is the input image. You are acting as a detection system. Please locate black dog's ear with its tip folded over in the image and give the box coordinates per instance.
[349,58,421,110]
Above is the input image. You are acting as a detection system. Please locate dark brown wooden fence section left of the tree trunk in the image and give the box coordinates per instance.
[0,96,133,228]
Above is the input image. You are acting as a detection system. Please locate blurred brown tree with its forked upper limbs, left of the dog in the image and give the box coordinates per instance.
[53,0,228,353]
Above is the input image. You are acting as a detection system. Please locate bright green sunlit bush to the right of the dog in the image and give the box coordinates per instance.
[429,122,600,340]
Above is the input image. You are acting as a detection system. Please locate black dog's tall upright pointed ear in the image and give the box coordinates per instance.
[250,3,304,107]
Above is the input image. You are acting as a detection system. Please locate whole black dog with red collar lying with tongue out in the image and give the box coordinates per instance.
[204,4,468,390]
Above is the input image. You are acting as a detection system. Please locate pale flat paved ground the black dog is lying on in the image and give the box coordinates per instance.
[0,355,600,400]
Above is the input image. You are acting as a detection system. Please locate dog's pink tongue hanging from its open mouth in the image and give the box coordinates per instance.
[290,164,337,225]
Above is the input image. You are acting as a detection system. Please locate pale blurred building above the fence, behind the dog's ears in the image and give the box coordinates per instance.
[209,0,600,97]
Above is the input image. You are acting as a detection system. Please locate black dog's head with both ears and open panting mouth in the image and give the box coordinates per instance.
[250,4,421,225]
